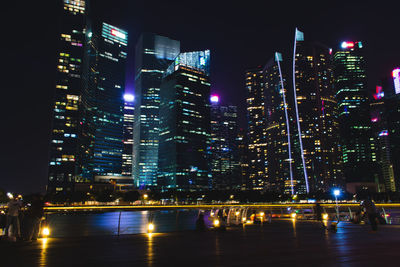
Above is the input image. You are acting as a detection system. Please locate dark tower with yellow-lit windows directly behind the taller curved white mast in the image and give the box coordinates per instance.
[293,36,346,192]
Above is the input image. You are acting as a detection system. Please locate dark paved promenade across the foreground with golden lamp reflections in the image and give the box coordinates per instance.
[0,220,400,267]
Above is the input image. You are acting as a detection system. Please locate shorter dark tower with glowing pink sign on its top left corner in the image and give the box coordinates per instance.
[210,98,241,190]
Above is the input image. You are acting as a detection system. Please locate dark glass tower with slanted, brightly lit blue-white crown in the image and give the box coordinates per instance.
[158,50,211,190]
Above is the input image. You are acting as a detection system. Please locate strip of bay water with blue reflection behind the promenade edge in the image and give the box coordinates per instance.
[47,210,208,237]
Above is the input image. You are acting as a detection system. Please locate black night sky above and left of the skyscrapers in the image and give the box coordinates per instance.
[0,0,400,193]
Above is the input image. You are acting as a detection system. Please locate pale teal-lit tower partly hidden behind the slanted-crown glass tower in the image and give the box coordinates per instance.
[132,33,180,188]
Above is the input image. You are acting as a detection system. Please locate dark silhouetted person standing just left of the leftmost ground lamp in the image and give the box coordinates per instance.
[24,195,44,241]
